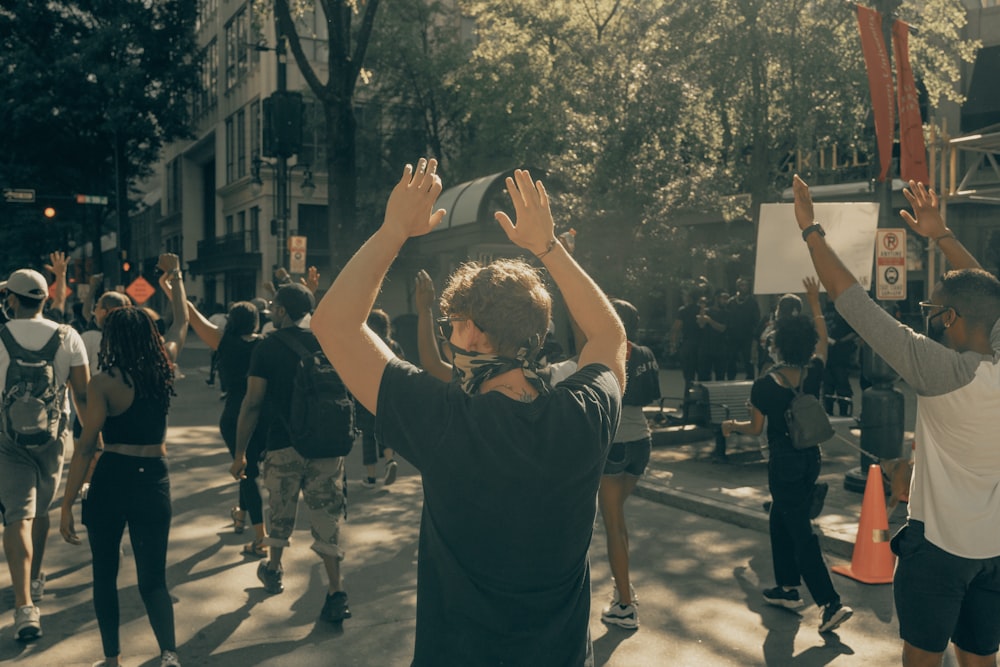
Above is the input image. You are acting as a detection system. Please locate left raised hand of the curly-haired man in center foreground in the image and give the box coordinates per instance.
[382,158,445,238]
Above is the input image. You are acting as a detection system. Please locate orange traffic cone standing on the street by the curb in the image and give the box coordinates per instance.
[832,465,896,584]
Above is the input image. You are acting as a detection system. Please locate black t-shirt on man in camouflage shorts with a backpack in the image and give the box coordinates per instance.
[247,326,320,451]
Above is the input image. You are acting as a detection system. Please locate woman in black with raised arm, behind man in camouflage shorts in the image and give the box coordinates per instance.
[187,301,267,558]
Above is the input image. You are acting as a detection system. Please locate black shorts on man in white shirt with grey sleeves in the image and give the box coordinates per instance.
[891,520,1000,655]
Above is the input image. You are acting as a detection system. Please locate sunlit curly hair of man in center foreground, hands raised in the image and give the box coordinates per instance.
[440,259,552,357]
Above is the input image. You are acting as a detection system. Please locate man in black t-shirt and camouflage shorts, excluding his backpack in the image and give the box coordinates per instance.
[232,283,351,623]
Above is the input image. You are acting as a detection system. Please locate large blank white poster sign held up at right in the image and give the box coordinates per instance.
[753,202,878,294]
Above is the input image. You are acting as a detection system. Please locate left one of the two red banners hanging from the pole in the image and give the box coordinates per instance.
[858,5,896,181]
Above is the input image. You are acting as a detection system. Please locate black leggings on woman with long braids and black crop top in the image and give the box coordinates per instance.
[83,452,177,657]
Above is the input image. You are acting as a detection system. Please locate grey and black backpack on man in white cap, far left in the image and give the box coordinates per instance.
[0,325,68,446]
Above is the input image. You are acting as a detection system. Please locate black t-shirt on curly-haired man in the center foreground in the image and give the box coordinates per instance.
[376,360,621,667]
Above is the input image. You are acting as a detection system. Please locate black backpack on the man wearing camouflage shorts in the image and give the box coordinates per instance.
[274,330,357,459]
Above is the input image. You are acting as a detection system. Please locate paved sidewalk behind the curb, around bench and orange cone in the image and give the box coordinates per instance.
[636,369,915,560]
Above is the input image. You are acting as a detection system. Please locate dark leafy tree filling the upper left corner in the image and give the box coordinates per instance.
[0,0,198,278]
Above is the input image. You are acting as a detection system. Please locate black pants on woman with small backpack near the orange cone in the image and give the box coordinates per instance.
[767,444,840,606]
